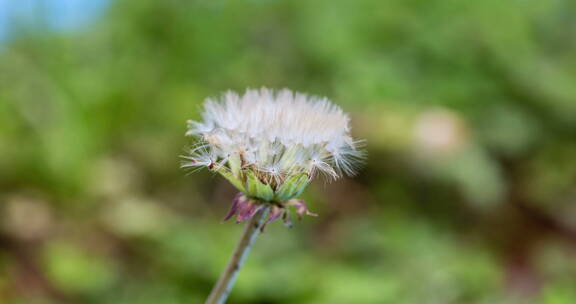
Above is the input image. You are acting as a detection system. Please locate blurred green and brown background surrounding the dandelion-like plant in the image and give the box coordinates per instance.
[0,0,576,304]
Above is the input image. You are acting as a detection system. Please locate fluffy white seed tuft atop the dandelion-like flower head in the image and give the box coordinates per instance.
[183,88,362,182]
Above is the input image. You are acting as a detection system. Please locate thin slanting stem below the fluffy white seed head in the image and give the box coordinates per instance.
[206,205,270,304]
